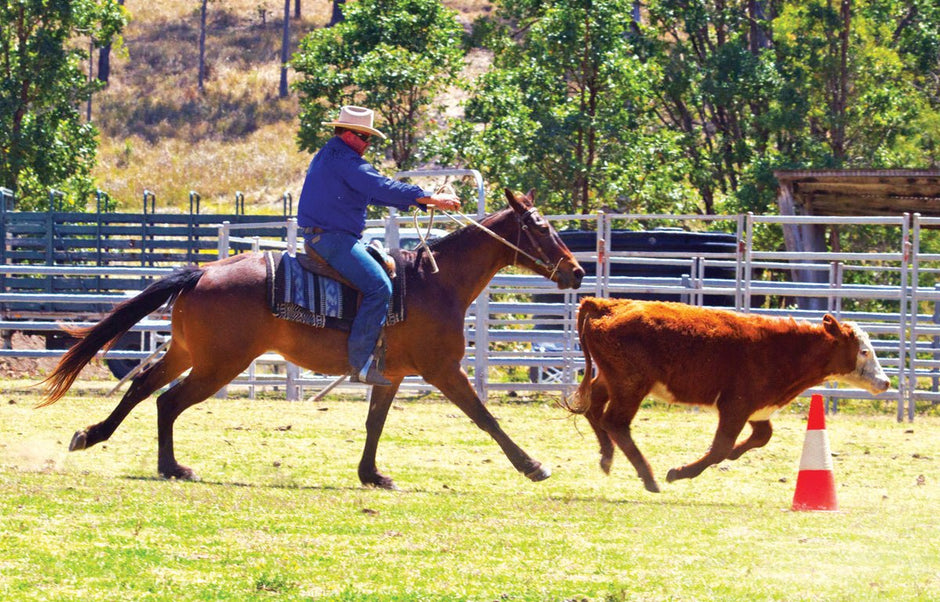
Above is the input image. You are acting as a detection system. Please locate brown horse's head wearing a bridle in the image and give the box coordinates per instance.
[506,188,584,289]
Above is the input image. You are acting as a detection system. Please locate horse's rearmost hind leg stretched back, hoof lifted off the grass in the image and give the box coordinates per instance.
[69,345,190,451]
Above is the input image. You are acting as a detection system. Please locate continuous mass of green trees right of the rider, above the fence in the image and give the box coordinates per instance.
[454,0,940,213]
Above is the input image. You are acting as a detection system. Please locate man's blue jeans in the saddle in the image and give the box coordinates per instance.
[307,232,392,372]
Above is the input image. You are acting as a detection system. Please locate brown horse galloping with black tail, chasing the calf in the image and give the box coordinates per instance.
[42,189,584,488]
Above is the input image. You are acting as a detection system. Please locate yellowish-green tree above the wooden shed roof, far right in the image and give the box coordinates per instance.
[774,0,938,167]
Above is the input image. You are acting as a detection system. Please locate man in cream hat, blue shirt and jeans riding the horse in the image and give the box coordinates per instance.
[297,106,460,385]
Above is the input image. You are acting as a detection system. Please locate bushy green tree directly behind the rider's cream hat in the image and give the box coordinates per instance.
[291,0,463,169]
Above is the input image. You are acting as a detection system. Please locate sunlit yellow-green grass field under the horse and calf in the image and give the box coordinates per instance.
[0,381,940,601]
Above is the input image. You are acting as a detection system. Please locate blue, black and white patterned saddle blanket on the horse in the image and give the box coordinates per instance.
[265,251,405,331]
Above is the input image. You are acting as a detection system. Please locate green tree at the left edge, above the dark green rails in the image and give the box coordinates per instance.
[0,0,126,208]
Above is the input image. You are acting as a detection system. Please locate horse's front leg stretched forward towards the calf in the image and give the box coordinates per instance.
[424,366,552,481]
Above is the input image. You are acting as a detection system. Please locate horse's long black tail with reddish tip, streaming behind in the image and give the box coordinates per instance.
[37,266,204,407]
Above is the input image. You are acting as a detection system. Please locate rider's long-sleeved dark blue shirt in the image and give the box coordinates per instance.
[297,136,431,237]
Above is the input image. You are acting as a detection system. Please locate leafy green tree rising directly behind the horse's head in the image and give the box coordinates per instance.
[456,0,682,214]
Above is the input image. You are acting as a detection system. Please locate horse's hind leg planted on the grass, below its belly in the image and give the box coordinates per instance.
[157,367,242,480]
